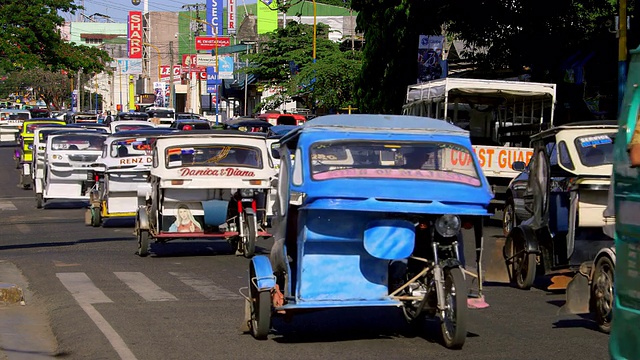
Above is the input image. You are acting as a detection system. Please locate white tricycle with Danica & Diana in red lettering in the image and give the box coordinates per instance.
[136,130,275,257]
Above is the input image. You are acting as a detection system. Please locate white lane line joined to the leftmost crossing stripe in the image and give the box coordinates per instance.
[56,272,136,360]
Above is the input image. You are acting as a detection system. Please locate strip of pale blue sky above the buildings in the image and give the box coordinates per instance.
[63,0,257,23]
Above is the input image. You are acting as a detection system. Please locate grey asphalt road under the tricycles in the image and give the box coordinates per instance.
[0,147,608,360]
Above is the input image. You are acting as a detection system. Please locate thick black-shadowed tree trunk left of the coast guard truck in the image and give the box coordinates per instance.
[351,0,445,114]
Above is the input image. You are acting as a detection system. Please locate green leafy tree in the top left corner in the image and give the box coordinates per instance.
[0,0,111,72]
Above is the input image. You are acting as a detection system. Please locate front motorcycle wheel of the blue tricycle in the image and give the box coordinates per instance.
[440,268,468,349]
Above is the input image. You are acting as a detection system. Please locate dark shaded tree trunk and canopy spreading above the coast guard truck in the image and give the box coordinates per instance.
[351,0,635,113]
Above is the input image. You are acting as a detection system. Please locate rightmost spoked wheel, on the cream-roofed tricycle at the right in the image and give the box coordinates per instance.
[591,256,614,334]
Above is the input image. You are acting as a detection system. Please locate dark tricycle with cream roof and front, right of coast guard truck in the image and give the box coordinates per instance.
[504,121,618,331]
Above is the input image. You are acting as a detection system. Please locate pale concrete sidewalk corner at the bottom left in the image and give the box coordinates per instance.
[0,260,57,360]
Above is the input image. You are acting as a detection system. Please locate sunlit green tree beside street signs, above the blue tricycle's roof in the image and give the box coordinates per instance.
[241,22,361,110]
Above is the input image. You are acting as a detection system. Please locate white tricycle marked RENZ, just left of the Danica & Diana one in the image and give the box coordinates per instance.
[86,128,172,227]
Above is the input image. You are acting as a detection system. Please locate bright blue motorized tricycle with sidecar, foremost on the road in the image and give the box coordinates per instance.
[245,115,493,348]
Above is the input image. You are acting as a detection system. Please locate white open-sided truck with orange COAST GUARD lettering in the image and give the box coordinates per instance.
[403,78,556,220]
